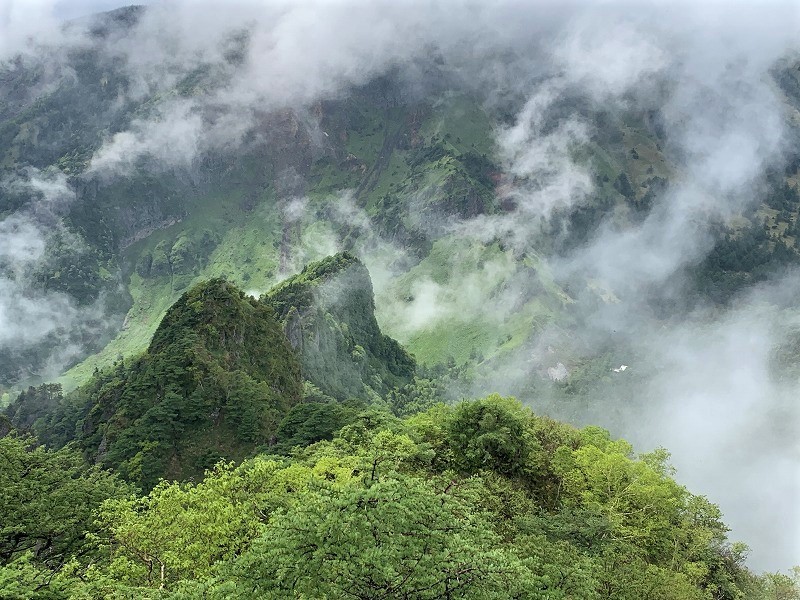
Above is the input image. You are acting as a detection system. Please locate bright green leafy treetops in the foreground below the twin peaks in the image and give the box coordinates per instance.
[0,396,797,600]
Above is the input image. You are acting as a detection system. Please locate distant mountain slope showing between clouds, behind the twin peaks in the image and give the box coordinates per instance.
[0,38,800,387]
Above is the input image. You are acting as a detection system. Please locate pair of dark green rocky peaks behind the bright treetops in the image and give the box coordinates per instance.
[17,253,416,489]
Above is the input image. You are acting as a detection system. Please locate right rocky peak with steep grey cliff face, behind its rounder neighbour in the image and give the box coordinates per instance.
[261,252,415,400]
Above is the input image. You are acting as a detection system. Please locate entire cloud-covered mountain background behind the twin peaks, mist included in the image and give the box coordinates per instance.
[0,1,800,567]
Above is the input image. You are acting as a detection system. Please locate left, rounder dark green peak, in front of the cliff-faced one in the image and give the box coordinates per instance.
[38,279,301,488]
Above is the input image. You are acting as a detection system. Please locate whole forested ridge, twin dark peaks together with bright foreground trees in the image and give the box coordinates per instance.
[0,253,798,600]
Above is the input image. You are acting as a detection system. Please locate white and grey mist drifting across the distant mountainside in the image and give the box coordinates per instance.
[0,0,800,568]
